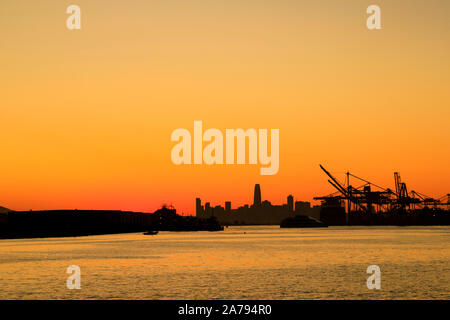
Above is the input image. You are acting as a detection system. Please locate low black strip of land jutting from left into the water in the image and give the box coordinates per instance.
[0,207,223,239]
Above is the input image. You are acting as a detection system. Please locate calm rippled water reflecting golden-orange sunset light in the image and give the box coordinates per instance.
[0,226,450,299]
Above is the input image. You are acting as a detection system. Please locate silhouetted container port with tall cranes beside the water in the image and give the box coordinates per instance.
[314,165,450,226]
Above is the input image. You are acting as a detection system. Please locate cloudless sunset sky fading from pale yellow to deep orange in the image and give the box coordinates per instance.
[0,0,450,213]
